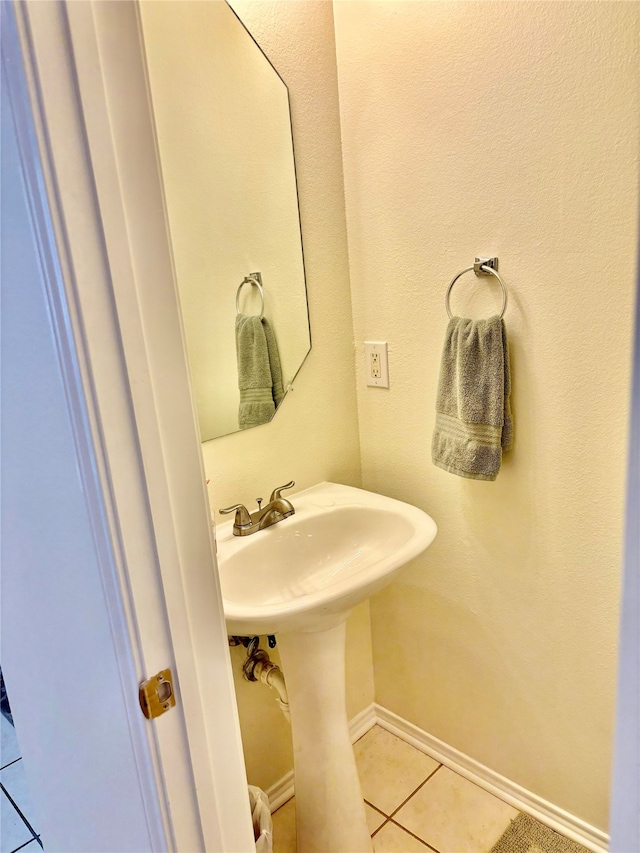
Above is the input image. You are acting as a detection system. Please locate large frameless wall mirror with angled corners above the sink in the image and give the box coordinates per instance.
[139,0,311,441]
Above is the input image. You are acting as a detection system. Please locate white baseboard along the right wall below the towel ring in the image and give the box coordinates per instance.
[375,705,609,853]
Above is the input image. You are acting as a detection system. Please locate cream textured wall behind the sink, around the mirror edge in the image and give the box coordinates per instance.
[198,0,373,788]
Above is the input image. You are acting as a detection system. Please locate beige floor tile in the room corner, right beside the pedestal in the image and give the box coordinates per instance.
[354,726,438,815]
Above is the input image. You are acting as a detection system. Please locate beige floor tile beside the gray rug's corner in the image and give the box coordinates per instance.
[394,767,518,853]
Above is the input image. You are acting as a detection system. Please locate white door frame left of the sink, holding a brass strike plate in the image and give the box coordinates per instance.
[3,0,254,851]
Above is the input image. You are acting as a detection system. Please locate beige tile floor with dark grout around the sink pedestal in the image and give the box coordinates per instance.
[273,726,518,853]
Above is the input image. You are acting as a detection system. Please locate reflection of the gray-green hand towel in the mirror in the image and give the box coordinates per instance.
[236,314,284,429]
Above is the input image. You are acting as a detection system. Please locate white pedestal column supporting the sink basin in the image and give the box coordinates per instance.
[278,616,373,853]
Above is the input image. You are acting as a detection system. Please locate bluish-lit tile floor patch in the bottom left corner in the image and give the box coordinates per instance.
[0,715,42,853]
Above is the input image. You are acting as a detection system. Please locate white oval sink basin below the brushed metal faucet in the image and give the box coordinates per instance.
[216,483,437,635]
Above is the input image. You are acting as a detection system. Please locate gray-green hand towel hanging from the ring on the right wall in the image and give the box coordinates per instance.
[431,316,513,480]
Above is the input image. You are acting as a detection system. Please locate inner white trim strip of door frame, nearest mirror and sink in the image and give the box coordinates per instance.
[60,2,253,851]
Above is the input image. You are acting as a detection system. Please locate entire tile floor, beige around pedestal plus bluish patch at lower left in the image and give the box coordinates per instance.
[0,716,580,853]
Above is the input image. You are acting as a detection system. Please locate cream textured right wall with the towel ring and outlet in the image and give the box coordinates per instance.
[335,0,640,827]
